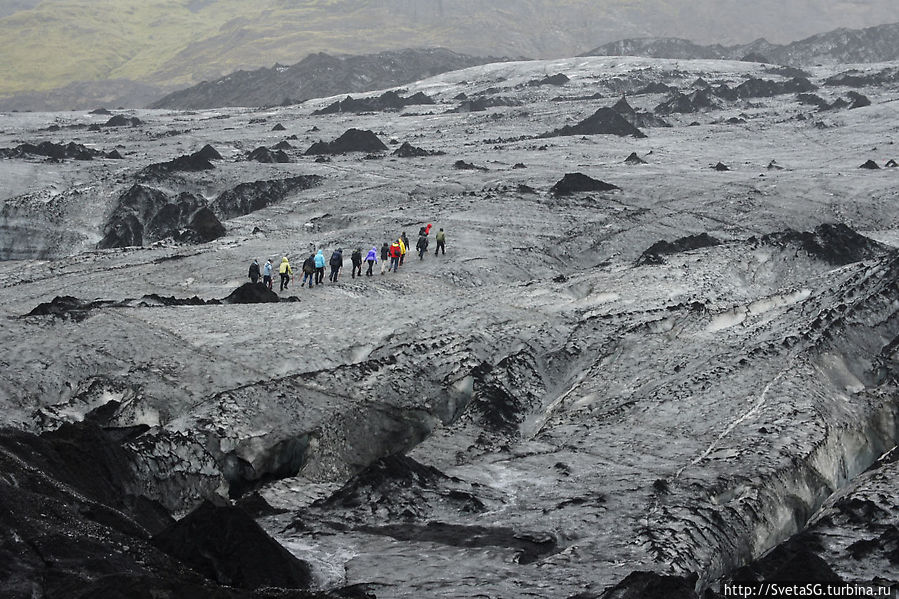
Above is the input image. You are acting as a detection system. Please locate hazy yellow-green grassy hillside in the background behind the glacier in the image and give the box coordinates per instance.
[0,0,895,96]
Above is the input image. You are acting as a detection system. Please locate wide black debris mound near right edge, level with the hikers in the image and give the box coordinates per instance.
[749,223,888,266]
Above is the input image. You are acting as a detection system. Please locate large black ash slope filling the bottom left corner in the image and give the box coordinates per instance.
[0,422,249,599]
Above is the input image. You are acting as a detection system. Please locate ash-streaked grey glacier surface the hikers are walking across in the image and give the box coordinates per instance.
[0,57,899,599]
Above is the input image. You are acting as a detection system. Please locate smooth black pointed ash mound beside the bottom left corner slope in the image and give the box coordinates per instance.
[153,502,312,589]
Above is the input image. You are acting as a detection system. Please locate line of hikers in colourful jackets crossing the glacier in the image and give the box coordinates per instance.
[248,224,446,291]
